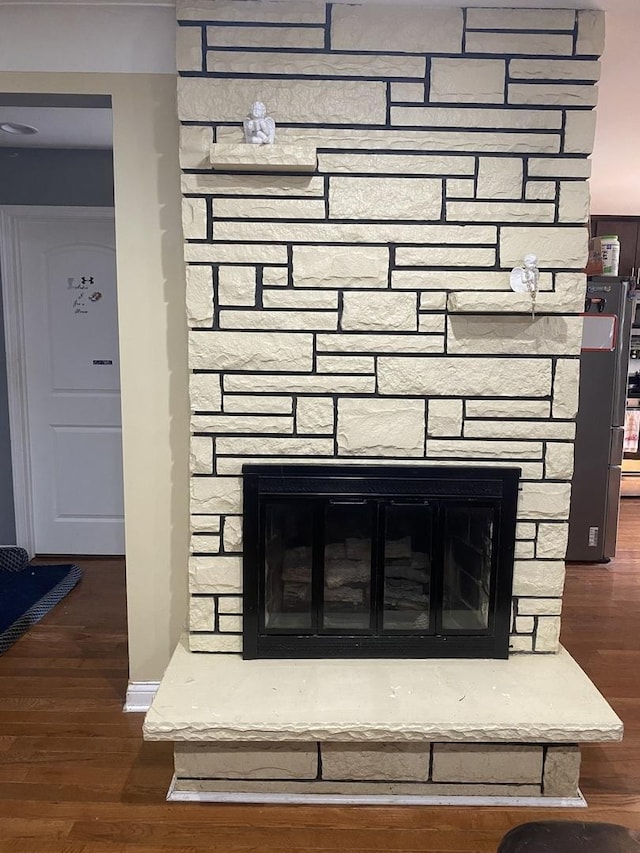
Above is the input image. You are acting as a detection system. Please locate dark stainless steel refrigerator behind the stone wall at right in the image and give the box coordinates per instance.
[567,277,635,563]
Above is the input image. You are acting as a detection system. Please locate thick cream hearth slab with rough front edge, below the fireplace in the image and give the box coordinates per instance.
[143,638,623,744]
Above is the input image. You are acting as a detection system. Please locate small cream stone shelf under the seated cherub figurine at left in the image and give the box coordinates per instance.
[211,143,318,172]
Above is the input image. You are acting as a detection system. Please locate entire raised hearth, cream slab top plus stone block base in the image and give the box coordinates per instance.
[144,640,622,805]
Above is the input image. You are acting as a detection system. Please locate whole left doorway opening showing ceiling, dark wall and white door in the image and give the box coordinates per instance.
[0,94,124,556]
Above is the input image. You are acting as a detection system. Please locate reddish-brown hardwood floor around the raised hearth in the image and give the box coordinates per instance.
[0,500,640,853]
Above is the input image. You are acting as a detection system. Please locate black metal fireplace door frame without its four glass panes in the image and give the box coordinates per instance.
[243,464,521,660]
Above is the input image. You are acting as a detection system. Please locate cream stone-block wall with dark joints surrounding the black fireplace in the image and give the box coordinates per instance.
[178,0,603,653]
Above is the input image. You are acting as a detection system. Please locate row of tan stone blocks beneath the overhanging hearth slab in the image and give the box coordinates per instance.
[175,741,580,797]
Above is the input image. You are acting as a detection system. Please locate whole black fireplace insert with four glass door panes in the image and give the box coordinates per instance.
[243,465,520,659]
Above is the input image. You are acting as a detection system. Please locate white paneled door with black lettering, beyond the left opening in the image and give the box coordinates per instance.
[4,208,124,555]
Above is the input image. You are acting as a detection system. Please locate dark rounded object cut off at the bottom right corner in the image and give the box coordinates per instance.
[498,820,640,853]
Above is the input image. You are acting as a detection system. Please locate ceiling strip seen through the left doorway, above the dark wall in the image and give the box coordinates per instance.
[0,105,113,148]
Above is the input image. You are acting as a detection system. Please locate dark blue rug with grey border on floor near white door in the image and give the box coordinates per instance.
[0,563,82,654]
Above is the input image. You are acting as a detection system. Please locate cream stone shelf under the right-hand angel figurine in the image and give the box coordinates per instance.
[447,290,582,316]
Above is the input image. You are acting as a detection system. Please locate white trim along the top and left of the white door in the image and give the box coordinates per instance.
[0,205,115,557]
